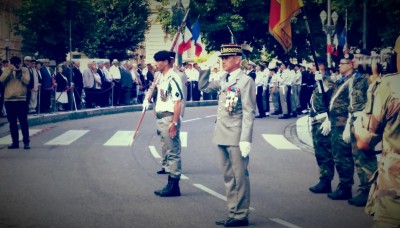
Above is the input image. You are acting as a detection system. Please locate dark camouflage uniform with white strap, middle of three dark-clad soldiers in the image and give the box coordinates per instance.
[329,76,354,188]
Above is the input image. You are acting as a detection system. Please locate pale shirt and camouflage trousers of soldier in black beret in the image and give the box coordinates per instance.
[155,69,184,178]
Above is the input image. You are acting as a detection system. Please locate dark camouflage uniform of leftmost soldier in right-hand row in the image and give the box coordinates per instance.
[310,77,335,182]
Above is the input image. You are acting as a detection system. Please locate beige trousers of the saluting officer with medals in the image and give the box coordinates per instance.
[218,145,250,219]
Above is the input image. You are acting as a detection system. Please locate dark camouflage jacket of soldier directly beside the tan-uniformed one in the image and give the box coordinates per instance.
[349,72,369,113]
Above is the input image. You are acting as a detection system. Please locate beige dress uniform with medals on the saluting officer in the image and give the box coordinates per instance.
[199,69,256,220]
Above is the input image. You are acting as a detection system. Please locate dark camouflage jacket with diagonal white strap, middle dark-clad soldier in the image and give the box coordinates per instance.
[329,76,353,126]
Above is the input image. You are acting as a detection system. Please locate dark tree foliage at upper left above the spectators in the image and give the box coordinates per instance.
[15,0,149,62]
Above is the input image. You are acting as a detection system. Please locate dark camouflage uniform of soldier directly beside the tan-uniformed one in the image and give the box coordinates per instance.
[349,73,378,194]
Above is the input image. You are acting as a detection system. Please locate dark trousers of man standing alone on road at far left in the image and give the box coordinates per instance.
[5,101,29,144]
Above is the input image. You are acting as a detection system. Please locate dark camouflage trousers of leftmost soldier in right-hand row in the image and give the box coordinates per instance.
[312,122,335,180]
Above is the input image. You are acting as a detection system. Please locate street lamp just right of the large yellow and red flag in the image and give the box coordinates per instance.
[319,0,339,67]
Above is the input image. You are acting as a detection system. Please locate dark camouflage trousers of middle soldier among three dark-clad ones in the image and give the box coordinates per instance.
[331,126,354,187]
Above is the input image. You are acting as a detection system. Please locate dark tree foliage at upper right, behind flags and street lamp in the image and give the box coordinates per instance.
[156,0,400,61]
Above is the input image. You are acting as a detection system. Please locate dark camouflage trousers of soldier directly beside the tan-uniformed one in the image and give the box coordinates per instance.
[351,126,378,190]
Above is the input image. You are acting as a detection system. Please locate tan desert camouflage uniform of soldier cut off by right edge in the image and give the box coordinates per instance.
[356,73,400,227]
